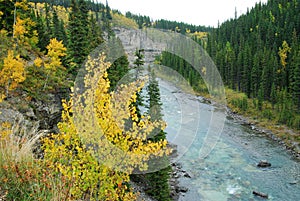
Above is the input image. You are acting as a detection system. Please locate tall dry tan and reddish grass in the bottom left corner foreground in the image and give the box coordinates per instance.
[0,115,71,201]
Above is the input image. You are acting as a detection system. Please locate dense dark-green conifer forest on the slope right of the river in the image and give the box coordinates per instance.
[160,0,300,129]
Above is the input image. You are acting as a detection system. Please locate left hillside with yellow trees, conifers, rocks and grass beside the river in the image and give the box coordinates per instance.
[0,0,171,200]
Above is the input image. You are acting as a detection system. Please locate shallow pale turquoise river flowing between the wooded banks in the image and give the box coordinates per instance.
[160,82,300,201]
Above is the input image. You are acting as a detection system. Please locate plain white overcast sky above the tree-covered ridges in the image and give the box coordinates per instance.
[98,0,267,27]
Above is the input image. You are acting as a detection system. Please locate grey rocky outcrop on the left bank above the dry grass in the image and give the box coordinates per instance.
[0,91,62,133]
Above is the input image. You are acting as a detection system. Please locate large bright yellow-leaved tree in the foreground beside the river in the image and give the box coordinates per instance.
[44,56,171,201]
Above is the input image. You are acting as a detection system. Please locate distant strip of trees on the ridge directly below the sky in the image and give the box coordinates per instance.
[125,12,212,34]
